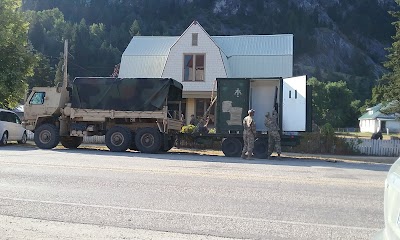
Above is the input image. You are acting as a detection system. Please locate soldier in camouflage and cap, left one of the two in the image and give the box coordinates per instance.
[242,109,256,159]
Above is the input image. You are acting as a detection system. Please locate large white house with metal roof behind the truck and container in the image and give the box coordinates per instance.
[118,21,293,124]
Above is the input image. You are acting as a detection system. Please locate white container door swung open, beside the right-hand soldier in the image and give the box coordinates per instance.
[282,76,307,132]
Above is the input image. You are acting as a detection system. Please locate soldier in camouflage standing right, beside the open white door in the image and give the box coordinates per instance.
[264,110,281,158]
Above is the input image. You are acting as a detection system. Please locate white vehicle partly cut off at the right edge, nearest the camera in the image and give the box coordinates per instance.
[374,158,400,240]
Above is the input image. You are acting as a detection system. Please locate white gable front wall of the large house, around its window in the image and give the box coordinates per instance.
[162,24,227,92]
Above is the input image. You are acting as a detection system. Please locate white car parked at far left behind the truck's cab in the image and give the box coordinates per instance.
[0,109,27,145]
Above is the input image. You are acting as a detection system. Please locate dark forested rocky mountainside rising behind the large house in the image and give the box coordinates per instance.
[23,0,397,100]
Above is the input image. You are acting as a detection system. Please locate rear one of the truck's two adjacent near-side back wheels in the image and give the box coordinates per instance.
[135,127,162,153]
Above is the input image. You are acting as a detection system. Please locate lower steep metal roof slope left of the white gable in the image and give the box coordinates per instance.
[118,56,167,78]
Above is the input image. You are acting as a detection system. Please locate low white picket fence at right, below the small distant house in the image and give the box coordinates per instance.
[347,138,400,157]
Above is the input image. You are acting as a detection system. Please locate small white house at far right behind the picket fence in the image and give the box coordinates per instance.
[358,103,400,133]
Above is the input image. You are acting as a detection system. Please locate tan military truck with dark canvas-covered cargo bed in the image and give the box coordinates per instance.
[23,77,182,153]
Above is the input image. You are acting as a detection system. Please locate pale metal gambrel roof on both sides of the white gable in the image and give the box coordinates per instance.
[119,22,293,78]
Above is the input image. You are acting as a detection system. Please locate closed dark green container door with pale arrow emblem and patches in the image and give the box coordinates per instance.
[216,78,250,133]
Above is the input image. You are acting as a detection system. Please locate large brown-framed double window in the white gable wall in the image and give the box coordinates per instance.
[183,54,205,81]
